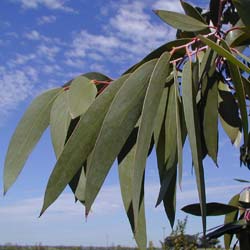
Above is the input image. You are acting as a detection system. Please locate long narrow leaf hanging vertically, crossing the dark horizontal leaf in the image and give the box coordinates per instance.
[182,61,206,232]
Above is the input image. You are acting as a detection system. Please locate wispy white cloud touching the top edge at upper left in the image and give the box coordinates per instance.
[17,0,75,12]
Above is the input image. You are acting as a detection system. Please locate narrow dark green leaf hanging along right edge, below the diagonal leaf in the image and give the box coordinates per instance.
[222,42,248,146]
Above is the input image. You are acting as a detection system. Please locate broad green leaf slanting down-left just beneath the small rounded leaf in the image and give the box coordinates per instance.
[41,75,128,214]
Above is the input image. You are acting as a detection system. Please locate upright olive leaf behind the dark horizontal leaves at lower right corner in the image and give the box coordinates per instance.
[224,194,240,249]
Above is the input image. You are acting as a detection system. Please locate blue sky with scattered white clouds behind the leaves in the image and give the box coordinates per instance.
[0,0,249,246]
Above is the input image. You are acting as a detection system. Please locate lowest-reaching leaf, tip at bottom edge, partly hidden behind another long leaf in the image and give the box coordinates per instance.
[118,145,147,249]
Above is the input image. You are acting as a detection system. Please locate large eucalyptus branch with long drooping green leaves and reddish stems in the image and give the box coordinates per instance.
[4,0,250,249]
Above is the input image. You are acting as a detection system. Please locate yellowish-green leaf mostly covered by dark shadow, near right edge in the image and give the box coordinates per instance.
[218,82,242,145]
